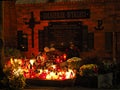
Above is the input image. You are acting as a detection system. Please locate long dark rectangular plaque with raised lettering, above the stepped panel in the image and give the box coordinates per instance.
[40,9,90,20]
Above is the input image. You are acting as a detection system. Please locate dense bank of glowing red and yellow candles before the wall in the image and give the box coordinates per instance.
[5,58,76,80]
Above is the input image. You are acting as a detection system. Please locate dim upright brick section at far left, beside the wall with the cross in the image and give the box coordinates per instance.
[3,1,17,47]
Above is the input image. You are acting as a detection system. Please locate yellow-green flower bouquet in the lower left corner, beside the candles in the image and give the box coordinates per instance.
[1,59,26,90]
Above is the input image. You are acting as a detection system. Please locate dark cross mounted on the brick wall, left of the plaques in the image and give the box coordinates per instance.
[25,12,40,48]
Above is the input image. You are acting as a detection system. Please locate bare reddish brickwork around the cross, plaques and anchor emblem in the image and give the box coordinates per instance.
[4,0,120,57]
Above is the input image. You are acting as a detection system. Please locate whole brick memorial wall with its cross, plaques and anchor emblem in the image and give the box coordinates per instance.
[4,0,120,57]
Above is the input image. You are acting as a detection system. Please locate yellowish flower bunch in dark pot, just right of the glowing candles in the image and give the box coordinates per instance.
[75,64,98,88]
